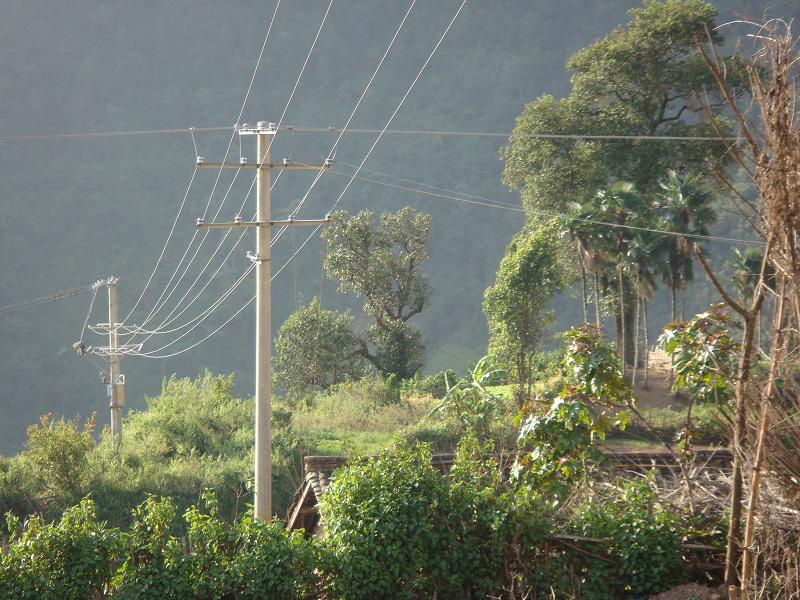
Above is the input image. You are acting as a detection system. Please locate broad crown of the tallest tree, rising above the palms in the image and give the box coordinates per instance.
[503,0,738,216]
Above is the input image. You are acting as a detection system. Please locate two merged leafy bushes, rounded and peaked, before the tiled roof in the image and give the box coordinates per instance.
[320,437,546,599]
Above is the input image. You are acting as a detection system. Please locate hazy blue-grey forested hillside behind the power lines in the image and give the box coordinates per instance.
[0,0,800,453]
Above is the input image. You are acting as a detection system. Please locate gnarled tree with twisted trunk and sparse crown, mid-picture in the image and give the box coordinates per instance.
[323,207,431,379]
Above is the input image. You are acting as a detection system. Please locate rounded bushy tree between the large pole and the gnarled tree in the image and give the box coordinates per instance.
[273,298,364,400]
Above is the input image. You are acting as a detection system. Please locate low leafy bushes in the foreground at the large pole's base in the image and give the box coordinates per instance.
[112,491,315,600]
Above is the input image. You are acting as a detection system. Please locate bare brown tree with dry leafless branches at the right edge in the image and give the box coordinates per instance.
[695,20,800,598]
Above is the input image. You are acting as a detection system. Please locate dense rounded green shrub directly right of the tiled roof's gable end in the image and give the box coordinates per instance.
[319,442,448,599]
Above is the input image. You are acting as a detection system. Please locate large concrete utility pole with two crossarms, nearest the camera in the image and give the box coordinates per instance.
[197,121,331,520]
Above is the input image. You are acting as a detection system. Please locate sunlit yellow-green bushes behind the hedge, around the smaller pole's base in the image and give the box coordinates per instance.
[0,373,299,531]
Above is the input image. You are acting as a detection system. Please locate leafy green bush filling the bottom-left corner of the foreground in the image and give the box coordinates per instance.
[0,499,120,600]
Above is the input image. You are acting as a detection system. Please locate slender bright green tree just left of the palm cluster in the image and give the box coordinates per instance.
[483,223,570,406]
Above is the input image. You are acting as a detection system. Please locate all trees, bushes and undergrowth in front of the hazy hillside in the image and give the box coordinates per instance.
[0,0,800,600]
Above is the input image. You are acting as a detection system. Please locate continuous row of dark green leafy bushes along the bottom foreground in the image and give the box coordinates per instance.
[0,438,686,600]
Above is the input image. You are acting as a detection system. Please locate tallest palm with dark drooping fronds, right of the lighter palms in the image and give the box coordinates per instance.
[658,170,717,321]
